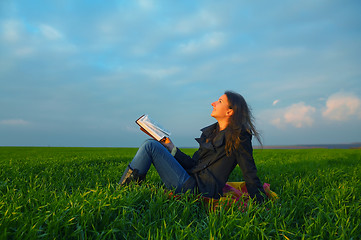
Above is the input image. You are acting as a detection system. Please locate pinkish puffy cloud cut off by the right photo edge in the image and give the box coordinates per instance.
[322,92,361,121]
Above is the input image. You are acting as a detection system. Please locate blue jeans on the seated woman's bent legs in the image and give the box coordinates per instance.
[130,139,195,192]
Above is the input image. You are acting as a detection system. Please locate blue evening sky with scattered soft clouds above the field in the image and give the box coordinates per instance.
[0,0,361,147]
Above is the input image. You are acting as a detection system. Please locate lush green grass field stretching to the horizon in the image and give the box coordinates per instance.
[0,147,361,239]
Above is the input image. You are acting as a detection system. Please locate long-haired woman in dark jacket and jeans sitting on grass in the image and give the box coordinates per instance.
[119,91,265,202]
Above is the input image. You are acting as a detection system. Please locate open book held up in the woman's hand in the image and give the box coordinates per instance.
[135,114,170,141]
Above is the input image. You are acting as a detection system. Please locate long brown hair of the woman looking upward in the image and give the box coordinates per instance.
[224,91,262,155]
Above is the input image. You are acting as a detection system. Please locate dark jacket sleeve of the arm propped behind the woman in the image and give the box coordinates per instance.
[236,134,265,202]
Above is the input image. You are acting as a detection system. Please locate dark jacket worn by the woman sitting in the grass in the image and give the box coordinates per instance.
[174,123,264,202]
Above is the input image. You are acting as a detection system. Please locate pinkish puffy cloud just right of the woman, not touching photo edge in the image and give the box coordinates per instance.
[270,102,316,128]
